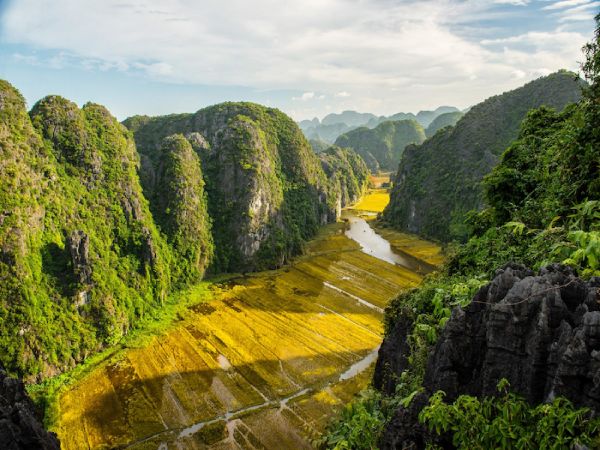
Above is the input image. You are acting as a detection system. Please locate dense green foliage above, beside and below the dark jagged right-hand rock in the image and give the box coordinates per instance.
[323,16,600,449]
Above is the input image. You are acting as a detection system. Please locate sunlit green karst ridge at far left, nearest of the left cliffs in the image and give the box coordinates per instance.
[0,81,178,379]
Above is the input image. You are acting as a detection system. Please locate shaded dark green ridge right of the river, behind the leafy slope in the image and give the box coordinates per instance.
[384,71,582,241]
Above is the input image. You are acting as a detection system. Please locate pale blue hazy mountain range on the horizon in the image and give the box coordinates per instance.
[298,106,461,143]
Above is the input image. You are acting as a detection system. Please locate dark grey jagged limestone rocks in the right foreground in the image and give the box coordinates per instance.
[374,265,600,448]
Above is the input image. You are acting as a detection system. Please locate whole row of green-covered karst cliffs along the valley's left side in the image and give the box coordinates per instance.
[0,90,368,380]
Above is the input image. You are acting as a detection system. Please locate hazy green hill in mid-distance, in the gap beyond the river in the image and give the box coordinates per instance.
[335,120,425,172]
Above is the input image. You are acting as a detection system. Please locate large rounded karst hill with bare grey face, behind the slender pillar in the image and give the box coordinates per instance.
[125,103,364,272]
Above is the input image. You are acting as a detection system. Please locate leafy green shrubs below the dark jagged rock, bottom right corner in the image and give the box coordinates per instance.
[419,380,600,450]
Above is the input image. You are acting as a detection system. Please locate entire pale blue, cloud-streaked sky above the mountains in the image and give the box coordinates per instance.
[0,0,600,120]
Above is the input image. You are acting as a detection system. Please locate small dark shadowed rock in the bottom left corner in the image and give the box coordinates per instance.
[0,369,60,450]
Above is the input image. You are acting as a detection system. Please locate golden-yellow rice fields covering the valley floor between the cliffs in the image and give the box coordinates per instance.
[55,188,439,449]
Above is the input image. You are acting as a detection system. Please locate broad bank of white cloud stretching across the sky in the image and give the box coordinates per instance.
[0,0,592,119]
